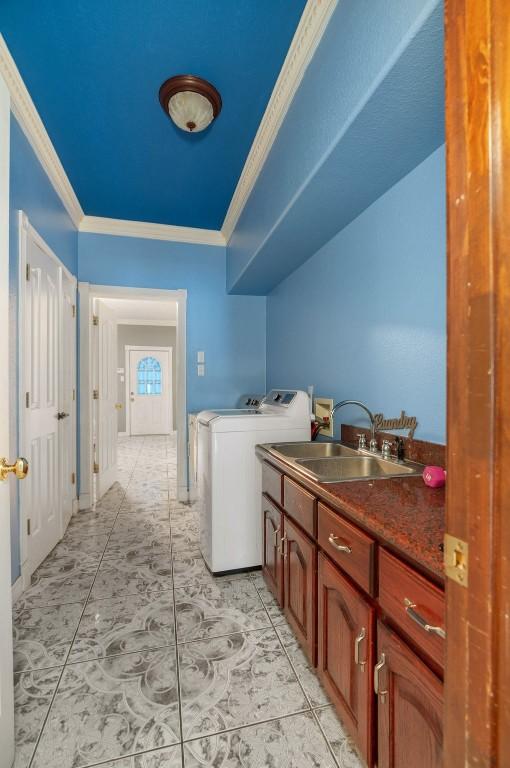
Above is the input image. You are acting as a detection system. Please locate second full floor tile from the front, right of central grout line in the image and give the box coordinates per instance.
[175,579,271,642]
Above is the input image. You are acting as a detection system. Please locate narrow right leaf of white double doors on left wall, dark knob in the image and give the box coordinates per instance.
[58,272,76,536]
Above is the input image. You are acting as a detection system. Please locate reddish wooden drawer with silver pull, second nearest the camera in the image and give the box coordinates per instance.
[318,504,375,595]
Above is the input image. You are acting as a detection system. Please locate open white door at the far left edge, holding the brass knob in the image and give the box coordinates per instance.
[0,70,14,768]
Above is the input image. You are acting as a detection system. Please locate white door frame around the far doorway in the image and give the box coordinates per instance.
[78,282,188,509]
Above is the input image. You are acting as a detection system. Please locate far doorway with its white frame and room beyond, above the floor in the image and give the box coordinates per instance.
[79,283,188,509]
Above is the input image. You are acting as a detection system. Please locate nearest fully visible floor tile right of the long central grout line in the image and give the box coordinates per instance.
[177,629,308,740]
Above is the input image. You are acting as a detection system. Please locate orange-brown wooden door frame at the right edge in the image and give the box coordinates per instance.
[444,0,510,768]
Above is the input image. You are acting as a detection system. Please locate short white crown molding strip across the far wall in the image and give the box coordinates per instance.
[79,216,226,246]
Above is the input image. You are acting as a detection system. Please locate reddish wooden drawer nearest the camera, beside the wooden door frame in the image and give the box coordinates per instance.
[379,549,445,667]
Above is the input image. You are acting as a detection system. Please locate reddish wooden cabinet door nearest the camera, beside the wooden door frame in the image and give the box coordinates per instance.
[374,622,443,768]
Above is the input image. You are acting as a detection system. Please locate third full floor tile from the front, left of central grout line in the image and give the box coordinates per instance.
[91,553,172,598]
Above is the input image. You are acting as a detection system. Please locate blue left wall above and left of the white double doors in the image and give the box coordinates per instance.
[9,116,78,583]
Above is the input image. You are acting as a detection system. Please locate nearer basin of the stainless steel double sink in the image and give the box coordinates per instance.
[296,455,423,483]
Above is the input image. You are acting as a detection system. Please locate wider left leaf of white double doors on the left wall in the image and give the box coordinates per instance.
[20,225,61,578]
